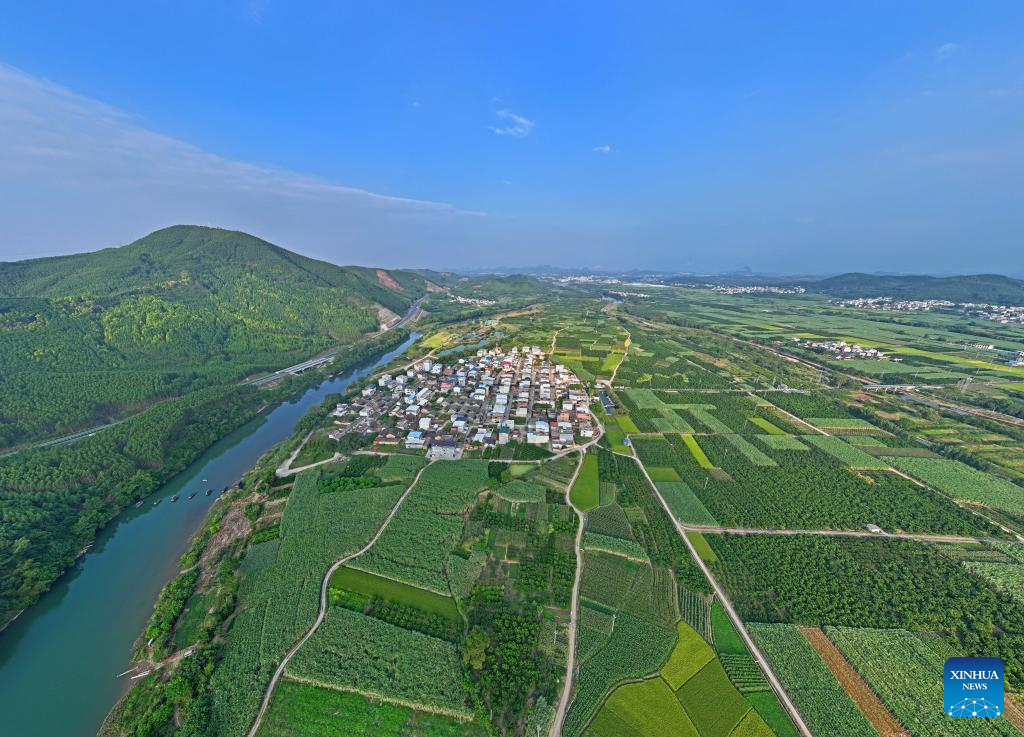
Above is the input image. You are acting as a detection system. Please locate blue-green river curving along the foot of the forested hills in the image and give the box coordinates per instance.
[0,333,419,737]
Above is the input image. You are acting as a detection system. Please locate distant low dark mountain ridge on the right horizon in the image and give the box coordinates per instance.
[804,273,1024,305]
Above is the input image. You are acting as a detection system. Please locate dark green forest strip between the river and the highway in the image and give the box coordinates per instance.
[0,330,409,627]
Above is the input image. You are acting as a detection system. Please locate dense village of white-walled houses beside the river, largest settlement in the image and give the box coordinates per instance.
[331,346,594,459]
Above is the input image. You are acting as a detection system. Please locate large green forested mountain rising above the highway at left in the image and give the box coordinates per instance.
[0,225,437,448]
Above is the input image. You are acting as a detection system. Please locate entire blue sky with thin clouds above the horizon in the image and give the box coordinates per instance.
[0,0,1024,273]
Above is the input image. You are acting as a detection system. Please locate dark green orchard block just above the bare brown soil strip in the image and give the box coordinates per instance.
[708,535,1024,686]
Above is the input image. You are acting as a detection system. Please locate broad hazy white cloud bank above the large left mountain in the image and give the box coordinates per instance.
[0,63,482,262]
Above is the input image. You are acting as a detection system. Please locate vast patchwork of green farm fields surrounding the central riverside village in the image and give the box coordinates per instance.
[101,287,1024,737]
